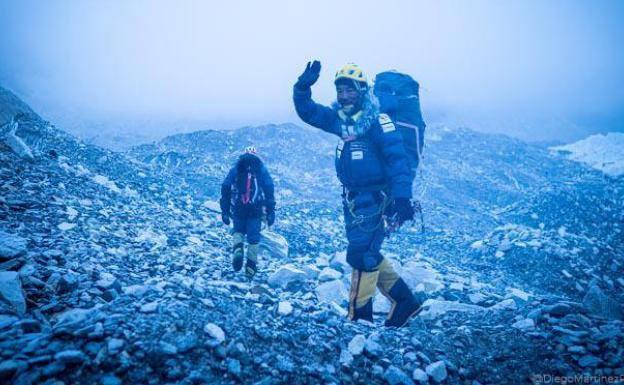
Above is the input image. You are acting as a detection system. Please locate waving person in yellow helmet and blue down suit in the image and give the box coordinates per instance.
[293,61,424,327]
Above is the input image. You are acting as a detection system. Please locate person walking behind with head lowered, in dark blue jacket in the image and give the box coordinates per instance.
[219,146,275,278]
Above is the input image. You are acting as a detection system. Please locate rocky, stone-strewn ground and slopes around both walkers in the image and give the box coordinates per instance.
[0,85,624,385]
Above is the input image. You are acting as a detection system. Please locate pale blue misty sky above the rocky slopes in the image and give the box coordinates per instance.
[0,0,624,139]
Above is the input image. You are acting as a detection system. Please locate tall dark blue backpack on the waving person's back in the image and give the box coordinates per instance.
[373,71,426,171]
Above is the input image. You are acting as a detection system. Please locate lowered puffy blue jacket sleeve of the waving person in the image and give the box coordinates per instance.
[373,114,414,199]
